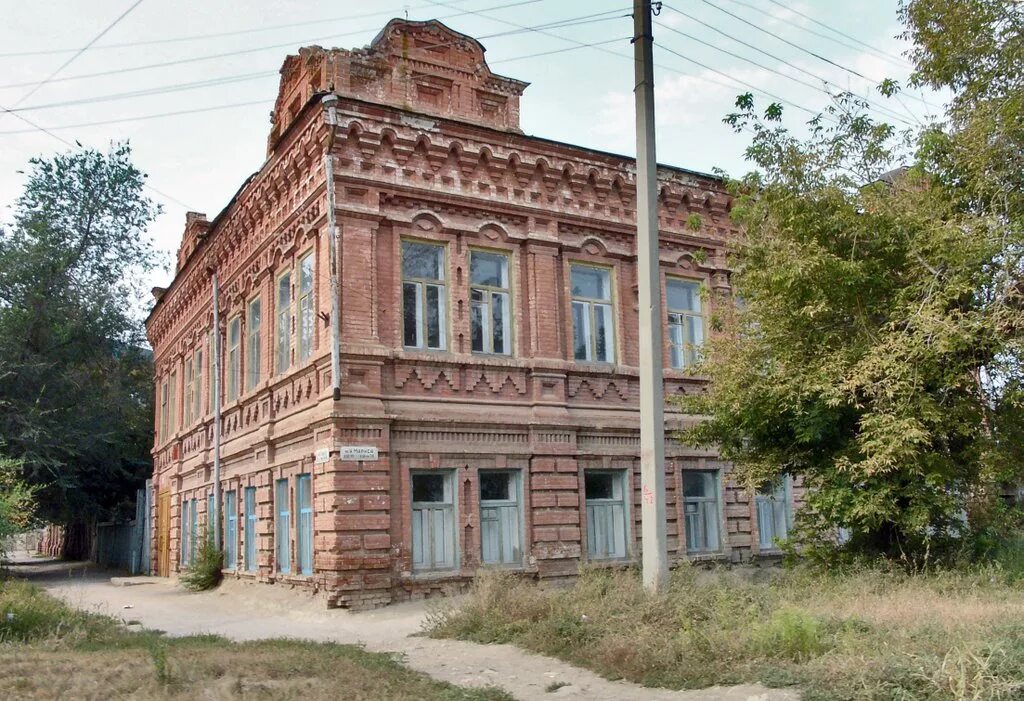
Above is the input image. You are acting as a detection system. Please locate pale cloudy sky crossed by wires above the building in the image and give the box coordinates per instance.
[0,0,942,286]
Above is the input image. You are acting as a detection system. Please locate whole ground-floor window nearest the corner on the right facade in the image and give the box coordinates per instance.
[411,472,456,571]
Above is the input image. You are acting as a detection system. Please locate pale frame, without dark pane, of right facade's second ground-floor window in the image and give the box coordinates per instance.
[477,470,523,567]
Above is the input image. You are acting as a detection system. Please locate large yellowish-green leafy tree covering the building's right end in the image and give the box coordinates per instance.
[684,0,1024,562]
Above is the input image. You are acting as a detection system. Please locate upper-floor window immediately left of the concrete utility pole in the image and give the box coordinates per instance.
[571,265,615,362]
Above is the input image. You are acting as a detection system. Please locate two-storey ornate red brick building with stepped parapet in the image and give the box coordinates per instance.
[147,19,792,606]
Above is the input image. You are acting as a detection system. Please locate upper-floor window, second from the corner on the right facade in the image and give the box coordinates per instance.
[469,251,512,355]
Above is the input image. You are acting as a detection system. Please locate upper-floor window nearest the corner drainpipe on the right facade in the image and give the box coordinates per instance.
[401,240,447,350]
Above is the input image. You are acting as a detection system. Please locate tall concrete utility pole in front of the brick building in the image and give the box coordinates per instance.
[633,0,669,590]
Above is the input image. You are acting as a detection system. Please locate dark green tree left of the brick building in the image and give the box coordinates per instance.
[0,144,159,555]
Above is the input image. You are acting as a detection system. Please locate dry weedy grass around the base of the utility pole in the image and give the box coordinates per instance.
[430,567,1024,701]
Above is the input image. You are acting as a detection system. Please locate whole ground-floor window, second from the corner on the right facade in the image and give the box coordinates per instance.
[480,470,522,565]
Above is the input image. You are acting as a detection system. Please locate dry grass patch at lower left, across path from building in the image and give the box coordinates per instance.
[0,581,511,701]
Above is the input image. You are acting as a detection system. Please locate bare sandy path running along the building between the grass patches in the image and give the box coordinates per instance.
[10,557,799,701]
